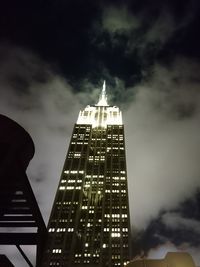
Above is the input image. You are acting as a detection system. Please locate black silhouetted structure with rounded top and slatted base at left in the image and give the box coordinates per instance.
[0,115,46,266]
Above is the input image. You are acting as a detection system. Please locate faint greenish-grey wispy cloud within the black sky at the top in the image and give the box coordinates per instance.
[95,3,196,64]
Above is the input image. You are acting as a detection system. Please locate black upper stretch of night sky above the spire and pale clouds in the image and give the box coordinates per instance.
[0,0,199,84]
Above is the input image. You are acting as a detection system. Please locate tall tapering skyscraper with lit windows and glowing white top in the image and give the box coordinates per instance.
[43,82,130,267]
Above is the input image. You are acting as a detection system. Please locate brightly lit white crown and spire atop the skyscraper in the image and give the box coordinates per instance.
[77,81,122,128]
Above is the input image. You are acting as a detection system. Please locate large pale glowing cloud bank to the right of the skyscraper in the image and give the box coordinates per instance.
[123,59,200,229]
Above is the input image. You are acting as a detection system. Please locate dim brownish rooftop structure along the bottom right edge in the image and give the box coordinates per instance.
[126,252,195,267]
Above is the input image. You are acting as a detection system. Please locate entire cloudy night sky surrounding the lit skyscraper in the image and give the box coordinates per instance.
[0,0,200,267]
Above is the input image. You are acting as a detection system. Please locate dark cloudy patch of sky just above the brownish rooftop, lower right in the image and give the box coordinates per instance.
[133,192,200,264]
